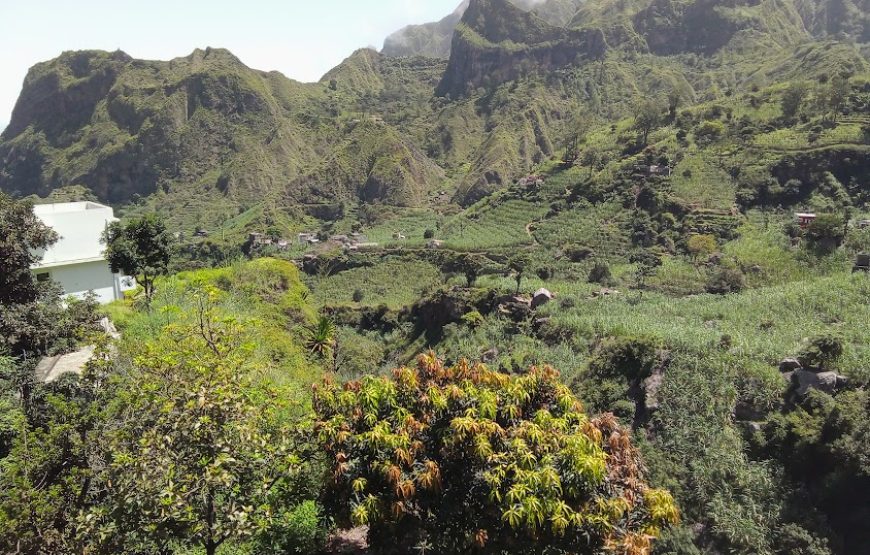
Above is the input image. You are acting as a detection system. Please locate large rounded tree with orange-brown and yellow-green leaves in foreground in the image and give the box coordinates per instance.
[314,353,677,554]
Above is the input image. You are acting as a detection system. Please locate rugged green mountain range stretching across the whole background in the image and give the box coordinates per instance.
[0,0,867,227]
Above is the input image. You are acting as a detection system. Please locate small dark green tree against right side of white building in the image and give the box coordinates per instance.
[103,214,172,305]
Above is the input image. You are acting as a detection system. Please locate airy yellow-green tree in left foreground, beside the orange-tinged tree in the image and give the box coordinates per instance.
[79,288,310,555]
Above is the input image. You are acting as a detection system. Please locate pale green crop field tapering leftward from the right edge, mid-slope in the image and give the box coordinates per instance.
[545,273,870,381]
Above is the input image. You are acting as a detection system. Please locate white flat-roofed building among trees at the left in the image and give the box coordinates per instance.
[31,202,136,303]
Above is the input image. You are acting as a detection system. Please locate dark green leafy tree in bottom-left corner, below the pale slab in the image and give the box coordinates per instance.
[0,347,114,555]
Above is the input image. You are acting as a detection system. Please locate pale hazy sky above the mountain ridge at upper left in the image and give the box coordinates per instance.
[0,0,460,129]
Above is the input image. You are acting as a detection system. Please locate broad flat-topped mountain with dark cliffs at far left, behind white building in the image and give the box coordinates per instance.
[0,49,328,203]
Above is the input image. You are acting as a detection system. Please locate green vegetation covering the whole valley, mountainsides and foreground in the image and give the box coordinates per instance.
[0,0,870,555]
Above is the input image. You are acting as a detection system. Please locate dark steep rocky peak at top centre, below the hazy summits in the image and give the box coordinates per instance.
[436,0,605,97]
